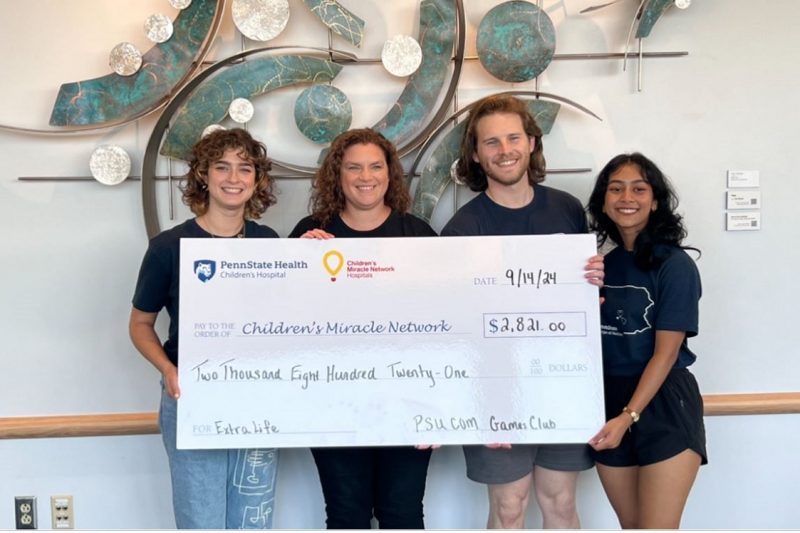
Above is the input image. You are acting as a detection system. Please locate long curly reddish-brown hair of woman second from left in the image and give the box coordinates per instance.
[310,128,411,227]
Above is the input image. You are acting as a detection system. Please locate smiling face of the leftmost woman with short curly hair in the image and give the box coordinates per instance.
[207,148,256,214]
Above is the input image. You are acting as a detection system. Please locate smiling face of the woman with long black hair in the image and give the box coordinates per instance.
[603,163,657,250]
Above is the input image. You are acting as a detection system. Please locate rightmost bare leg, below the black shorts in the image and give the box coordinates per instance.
[639,450,701,529]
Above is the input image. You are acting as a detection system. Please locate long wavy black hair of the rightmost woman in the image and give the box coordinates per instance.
[586,152,700,270]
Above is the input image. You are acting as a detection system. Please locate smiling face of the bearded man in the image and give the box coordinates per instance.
[473,113,536,189]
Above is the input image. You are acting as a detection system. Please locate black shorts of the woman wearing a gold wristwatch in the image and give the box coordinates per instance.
[592,368,708,466]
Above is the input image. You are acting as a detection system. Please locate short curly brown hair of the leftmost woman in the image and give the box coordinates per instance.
[181,128,275,220]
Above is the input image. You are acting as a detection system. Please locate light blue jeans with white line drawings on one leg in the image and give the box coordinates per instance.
[159,388,278,529]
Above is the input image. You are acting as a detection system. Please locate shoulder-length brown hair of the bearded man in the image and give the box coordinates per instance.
[456,94,546,192]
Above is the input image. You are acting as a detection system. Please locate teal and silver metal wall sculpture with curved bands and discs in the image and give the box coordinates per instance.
[0,0,690,236]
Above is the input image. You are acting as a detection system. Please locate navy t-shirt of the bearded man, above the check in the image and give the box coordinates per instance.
[442,184,589,236]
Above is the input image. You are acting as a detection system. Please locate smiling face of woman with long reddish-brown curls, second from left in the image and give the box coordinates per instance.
[339,143,389,216]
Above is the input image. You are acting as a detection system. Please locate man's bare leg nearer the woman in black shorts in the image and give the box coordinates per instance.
[533,466,581,529]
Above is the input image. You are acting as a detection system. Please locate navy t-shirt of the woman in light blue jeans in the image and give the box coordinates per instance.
[133,218,278,365]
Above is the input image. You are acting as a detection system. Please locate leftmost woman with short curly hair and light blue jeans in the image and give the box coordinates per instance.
[129,129,278,529]
